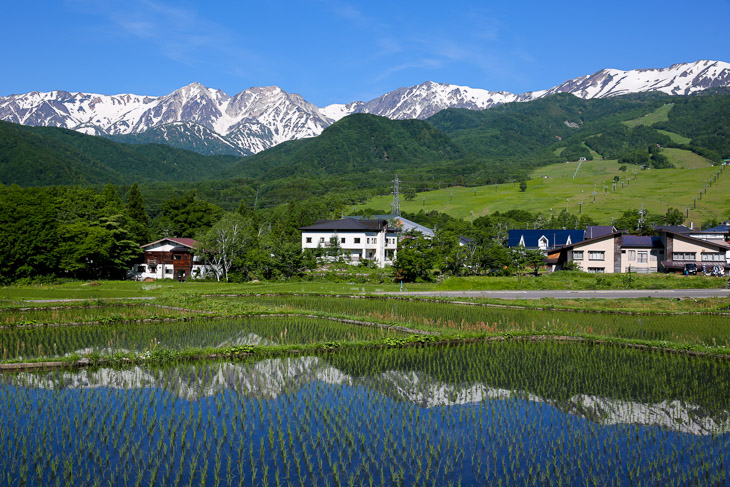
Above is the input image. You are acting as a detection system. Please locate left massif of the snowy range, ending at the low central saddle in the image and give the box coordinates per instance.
[0,83,333,154]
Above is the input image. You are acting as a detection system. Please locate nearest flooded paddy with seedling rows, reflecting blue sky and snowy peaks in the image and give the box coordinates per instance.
[0,341,730,486]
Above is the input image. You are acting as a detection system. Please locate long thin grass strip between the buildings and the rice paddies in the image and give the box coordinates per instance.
[0,272,727,308]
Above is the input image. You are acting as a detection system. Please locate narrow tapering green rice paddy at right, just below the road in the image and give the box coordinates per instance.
[222,295,730,348]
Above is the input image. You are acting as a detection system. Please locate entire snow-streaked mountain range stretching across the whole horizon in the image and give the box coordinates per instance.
[0,61,730,154]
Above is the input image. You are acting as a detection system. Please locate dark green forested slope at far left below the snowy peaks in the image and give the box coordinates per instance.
[0,122,238,186]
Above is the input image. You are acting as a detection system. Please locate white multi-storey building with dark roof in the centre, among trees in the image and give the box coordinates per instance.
[299,218,398,267]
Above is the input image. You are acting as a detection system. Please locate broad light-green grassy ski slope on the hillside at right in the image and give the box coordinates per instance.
[362,158,730,224]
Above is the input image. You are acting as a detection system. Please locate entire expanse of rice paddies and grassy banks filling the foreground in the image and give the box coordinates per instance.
[0,286,730,486]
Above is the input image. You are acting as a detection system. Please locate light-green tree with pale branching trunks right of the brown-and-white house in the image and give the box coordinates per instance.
[196,213,250,281]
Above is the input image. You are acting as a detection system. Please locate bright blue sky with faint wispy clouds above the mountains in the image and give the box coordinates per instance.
[0,0,730,106]
